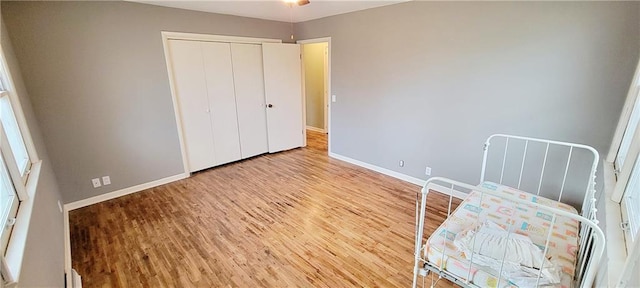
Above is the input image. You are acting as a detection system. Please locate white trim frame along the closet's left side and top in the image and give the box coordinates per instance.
[161,31,282,175]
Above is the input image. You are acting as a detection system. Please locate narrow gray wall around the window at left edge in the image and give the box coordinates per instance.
[0,21,64,287]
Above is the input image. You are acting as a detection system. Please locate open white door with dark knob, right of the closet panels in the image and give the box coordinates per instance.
[262,43,304,153]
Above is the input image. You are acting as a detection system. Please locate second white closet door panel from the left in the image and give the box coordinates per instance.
[201,42,241,165]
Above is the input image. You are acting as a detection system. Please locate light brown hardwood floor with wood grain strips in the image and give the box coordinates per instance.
[69,132,452,287]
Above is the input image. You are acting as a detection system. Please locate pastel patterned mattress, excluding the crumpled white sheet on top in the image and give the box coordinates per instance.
[424,182,579,288]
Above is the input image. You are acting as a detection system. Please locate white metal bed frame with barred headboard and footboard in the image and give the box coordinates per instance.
[412,134,605,288]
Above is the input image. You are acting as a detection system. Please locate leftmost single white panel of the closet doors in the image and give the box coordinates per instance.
[169,40,215,172]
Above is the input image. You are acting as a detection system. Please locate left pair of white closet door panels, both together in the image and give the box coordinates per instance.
[169,40,241,172]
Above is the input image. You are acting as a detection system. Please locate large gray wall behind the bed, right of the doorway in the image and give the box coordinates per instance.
[296,1,640,206]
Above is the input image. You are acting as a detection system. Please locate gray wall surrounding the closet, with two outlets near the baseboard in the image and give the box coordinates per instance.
[2,1,290,202]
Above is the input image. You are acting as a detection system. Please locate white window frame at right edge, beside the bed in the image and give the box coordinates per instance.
[604,55,640,286]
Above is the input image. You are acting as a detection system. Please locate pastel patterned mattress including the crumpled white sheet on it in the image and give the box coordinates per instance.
[425,182,578,288]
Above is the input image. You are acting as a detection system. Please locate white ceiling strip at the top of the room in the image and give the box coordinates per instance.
[126,0,410,22]
